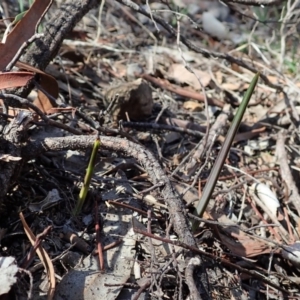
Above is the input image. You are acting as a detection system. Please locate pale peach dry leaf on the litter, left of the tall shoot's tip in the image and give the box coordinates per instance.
[168,64,211,90]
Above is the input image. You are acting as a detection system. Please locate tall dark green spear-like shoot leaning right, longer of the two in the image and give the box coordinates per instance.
[192,73,259,231]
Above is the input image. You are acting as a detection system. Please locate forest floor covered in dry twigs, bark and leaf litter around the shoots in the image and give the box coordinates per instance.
[0,0,300,300]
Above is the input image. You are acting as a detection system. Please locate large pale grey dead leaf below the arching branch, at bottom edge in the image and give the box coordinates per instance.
[55,208,137,300]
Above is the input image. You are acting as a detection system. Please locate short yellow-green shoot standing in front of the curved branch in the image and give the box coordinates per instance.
[73,137,100,216]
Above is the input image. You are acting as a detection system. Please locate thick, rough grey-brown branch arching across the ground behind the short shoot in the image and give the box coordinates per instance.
[22,136,209,299]
